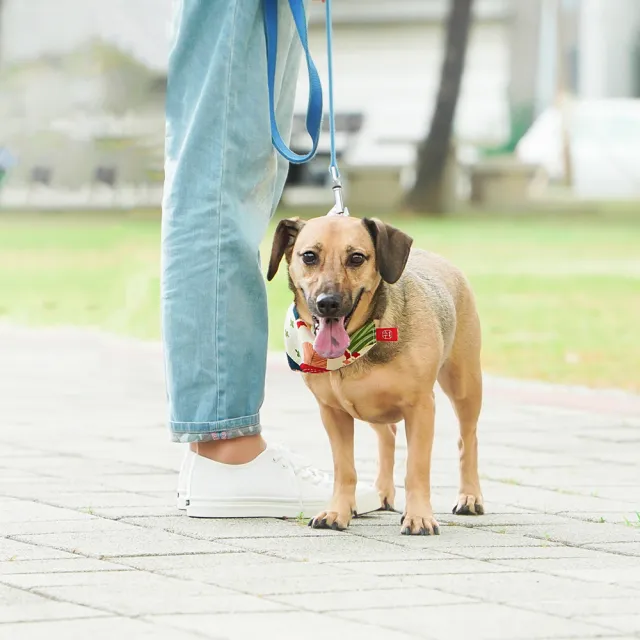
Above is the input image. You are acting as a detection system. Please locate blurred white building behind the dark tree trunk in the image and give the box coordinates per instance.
[292,0,512,202]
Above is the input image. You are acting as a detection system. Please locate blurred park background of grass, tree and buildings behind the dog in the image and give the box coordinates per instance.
[0,0,640,392]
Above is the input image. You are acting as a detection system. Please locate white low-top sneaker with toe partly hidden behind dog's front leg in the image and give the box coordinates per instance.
[178,445,380,518]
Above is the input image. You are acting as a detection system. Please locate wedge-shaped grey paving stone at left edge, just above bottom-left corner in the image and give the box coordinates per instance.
[0,585,100,624]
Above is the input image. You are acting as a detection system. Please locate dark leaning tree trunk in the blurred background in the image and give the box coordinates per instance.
[407,0,473,214]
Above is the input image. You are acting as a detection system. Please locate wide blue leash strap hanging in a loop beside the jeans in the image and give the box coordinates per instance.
[262,0,322,164]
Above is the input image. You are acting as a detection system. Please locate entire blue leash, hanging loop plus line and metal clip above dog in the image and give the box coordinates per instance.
[262,0,348,215]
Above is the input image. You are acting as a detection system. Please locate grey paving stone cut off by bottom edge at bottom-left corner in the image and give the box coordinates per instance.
[0,616,208,640]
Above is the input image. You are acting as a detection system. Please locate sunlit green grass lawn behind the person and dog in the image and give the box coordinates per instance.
[0,213,640,391]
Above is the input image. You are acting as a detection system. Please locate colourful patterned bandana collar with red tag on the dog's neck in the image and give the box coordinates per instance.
[284,304,398,373]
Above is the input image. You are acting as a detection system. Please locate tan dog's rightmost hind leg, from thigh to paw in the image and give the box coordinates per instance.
[438,310,484,515]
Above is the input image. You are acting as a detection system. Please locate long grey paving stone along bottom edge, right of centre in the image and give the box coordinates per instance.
[339,603,610,640]
